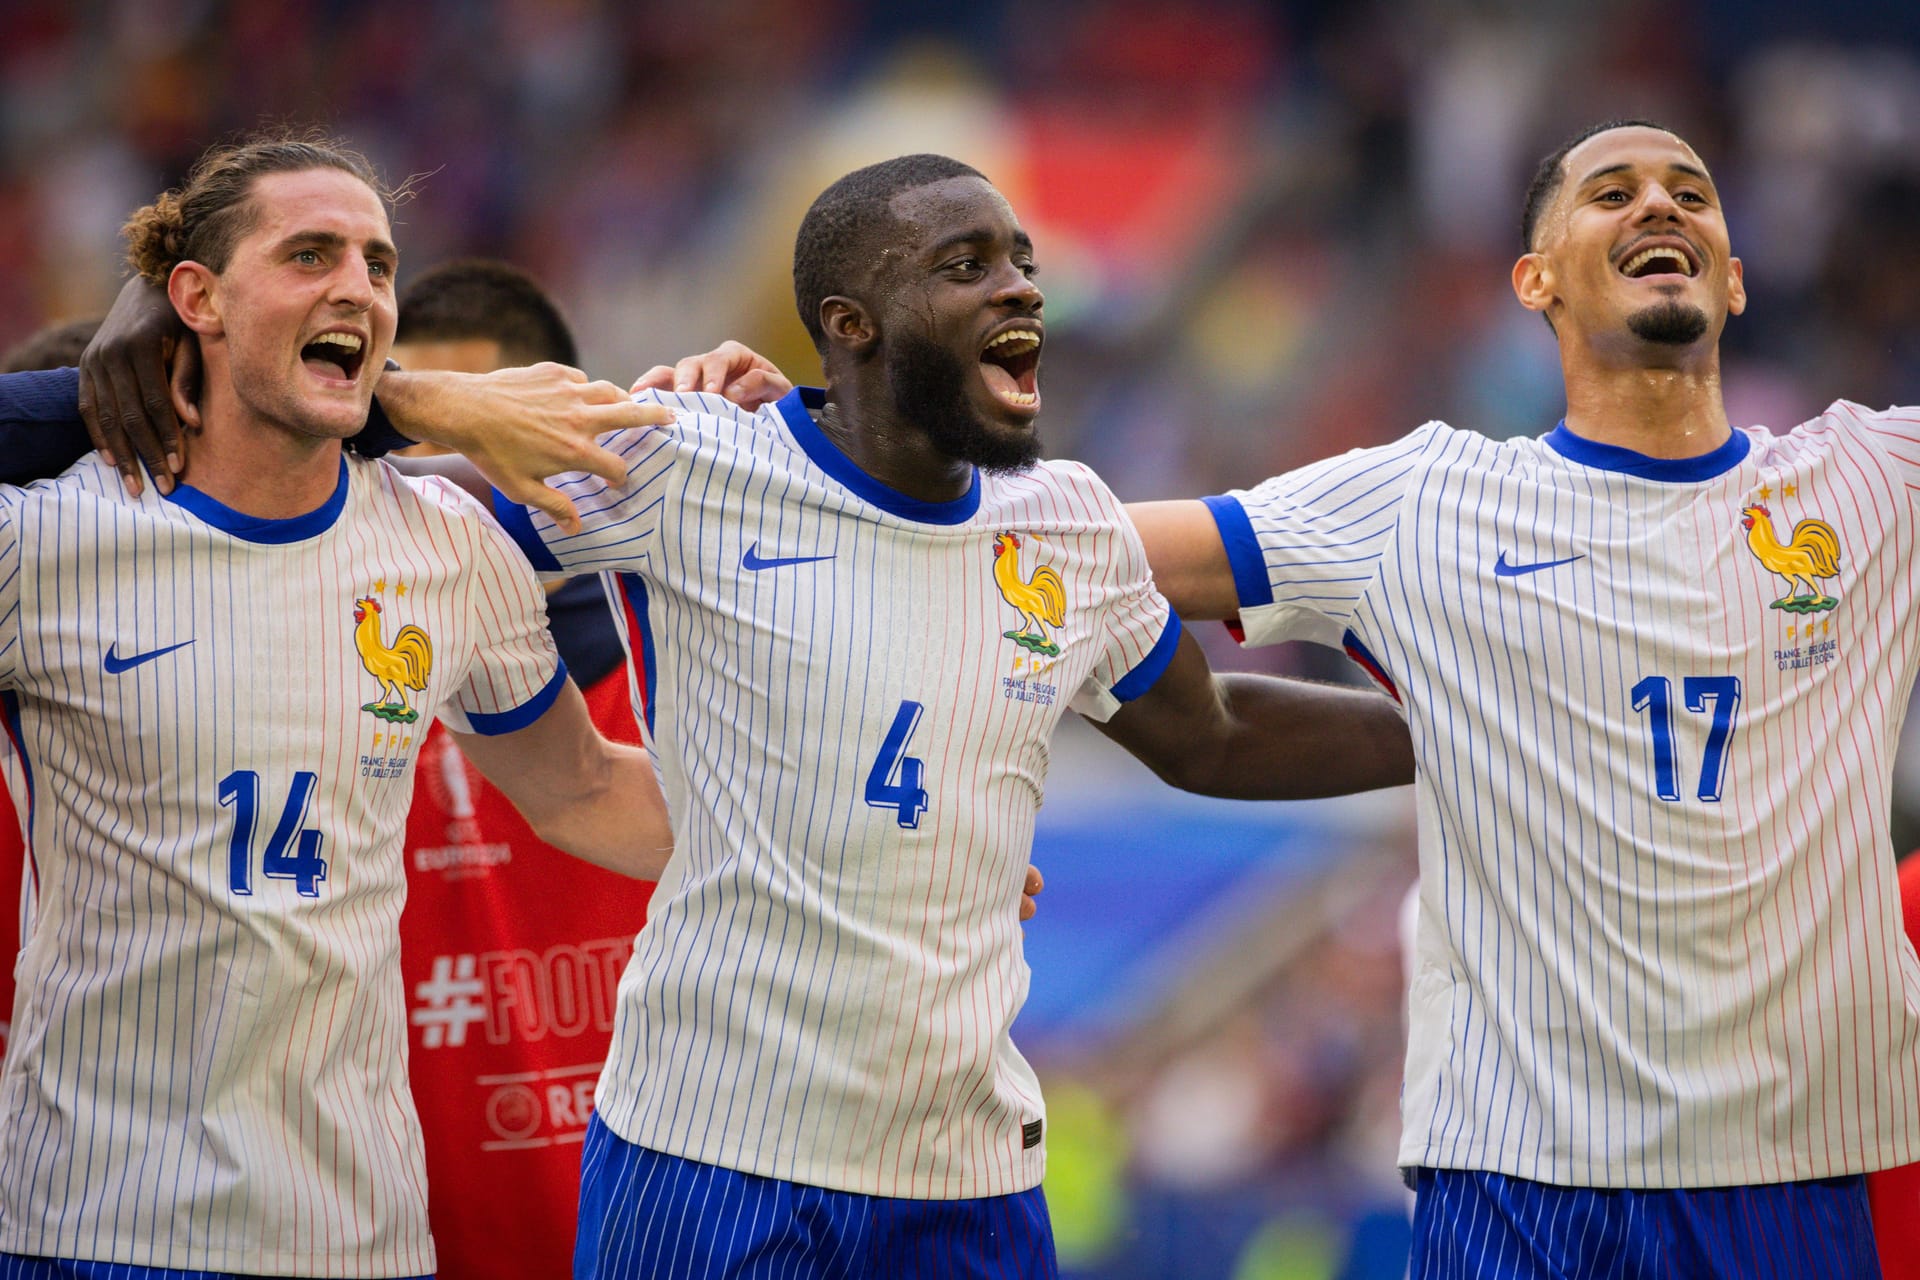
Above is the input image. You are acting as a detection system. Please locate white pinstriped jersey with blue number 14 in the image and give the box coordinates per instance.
[0,455,564,1276]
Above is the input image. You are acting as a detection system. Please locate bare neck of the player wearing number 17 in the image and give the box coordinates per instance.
[1561,342,1732,459]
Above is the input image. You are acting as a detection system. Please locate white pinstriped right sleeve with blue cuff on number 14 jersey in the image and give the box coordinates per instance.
[440,514,566,735]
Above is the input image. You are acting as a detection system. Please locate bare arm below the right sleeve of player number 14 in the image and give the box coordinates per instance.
[453,679,674,881]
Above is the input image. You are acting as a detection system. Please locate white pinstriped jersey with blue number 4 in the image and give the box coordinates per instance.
[501,390,1179,1199]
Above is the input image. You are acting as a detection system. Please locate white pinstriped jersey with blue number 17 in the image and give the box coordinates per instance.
[1208,403,1920,1186]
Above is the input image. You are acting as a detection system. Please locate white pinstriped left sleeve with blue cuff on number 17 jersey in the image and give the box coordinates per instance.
[1202,422,1450,645]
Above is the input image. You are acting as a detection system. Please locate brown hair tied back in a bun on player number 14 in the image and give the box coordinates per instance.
[121,129,389,284]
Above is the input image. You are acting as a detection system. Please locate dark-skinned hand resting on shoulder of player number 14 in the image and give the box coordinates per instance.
[81,276,200,497]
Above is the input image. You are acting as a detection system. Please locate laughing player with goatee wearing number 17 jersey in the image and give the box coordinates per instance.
[1133,121,1920,1276]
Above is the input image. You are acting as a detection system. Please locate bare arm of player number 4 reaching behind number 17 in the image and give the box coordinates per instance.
[1098,635,1413,800]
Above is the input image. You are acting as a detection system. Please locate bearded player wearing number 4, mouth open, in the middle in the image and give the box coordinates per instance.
[480,155,1411,1278]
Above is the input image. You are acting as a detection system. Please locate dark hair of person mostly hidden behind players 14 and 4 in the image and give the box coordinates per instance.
[394,257,580,365]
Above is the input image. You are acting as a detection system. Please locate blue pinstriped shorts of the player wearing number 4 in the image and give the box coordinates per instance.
[574,1115,1060,1280]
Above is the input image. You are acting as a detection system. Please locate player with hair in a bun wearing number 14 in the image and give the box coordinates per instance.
[0,127,670,1276]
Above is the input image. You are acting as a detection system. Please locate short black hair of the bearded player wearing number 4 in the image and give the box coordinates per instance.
[793,154,987,353]
